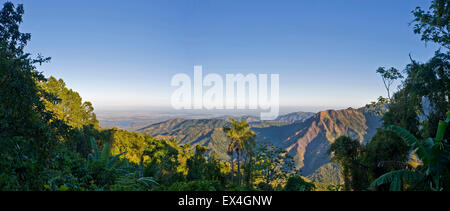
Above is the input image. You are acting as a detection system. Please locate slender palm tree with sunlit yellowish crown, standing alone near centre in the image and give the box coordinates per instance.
[224,119,256,185]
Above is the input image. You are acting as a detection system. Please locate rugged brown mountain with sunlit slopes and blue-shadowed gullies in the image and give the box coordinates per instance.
[256,108,380,175]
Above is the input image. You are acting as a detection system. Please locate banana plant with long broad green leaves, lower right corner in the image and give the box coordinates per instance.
[369,111,450,191]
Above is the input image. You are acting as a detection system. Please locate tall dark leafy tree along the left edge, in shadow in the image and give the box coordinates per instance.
[0,2,62,190]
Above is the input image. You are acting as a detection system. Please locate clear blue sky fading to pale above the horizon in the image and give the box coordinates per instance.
[8,0,437,110]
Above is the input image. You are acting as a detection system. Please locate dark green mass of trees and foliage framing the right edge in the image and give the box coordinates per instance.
[330,0,450,191]
